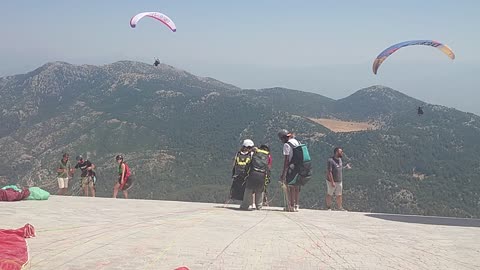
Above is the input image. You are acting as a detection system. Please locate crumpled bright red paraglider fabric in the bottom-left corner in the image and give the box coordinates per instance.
[0,224,35,270]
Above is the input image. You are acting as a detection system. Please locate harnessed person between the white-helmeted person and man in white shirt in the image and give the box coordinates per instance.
[240,145,271,210]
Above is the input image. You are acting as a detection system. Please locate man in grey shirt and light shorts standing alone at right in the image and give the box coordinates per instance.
[325,147,351,211]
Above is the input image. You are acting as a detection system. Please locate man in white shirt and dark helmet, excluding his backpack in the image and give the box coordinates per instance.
[278,129,300,212]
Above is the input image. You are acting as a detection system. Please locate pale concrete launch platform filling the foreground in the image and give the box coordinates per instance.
[0,196,480,270]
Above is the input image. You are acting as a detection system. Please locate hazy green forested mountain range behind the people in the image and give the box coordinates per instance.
[0,61,480,217]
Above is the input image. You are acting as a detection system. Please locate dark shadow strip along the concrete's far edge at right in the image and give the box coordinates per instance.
[365,214,480,227]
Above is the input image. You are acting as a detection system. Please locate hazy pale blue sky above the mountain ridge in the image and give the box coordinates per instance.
[0,0,480,114]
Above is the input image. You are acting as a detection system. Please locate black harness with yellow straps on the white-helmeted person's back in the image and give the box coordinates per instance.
[230,152,252,201]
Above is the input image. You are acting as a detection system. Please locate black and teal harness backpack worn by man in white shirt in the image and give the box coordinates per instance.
[287,142,312,186]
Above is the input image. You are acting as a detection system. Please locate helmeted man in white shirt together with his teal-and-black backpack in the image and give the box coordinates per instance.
[278,129,311,212]
